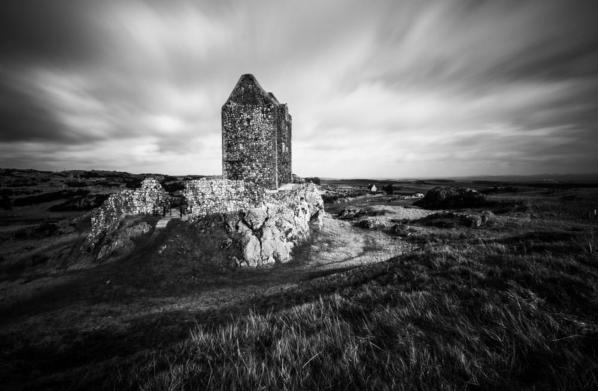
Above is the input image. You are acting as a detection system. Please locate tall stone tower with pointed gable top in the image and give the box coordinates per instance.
[222,74,292,189]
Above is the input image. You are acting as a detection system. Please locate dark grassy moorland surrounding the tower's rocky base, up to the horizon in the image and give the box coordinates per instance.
[0,169,598,390]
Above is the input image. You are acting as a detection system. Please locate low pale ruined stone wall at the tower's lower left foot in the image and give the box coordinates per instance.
[183,179,265,220]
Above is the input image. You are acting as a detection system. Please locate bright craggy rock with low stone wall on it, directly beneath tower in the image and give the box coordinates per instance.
[184,179,324,267]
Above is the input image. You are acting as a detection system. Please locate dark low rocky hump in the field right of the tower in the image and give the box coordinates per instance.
[415,187,486,209]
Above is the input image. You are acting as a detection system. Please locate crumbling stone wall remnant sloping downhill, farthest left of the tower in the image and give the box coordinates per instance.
[87,178,168,250]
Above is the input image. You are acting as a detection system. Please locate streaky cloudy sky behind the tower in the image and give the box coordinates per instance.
[0,0,598,178]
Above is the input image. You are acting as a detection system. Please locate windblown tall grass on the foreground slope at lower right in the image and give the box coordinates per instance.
[104,234,598,389]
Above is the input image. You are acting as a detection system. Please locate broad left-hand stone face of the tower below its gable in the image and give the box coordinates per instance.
[222,102,279,189]
